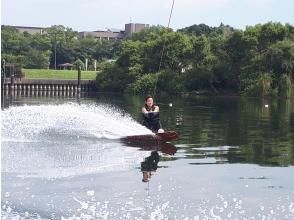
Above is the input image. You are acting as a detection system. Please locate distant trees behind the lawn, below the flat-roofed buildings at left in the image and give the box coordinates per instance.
[1,25,117,69]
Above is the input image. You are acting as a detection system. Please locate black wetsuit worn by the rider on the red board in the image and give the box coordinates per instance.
[142,105,162,132]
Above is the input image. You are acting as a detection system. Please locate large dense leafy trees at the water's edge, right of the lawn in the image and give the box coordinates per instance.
[97,22,294,96]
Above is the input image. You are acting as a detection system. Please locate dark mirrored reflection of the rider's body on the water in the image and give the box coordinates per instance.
[141,151,160,182]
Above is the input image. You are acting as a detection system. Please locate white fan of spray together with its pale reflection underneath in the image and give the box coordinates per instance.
[1,103,151,178]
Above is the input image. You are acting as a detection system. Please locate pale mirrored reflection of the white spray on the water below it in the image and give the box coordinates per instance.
[2,139,146,179]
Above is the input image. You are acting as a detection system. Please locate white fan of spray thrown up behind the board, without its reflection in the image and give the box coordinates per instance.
[1,103,151,141]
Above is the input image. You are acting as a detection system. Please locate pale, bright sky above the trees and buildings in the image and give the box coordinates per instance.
[1,0,294,31]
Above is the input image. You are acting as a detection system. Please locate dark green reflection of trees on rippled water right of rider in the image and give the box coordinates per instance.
[162,98,294,166]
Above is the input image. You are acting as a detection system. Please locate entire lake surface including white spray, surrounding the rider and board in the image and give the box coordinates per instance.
[1,94,294,220]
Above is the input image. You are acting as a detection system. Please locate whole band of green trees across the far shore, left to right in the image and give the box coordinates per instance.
[1,22,294,97]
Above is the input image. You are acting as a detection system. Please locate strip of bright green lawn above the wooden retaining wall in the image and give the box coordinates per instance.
[22,69,97,80]
